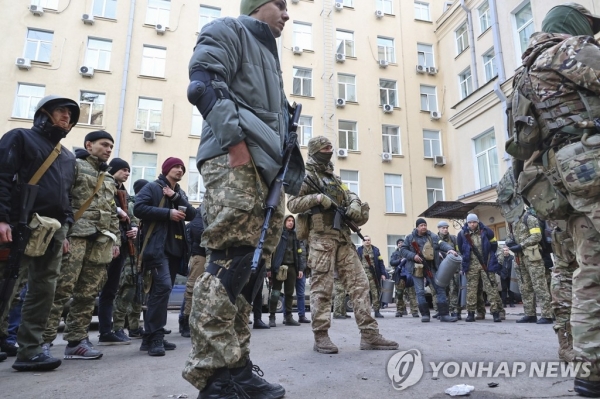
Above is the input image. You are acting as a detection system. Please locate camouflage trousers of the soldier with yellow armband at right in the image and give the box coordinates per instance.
[513,255,552,318]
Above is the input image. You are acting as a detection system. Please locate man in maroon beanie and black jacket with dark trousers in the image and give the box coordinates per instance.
[133,157,196,356]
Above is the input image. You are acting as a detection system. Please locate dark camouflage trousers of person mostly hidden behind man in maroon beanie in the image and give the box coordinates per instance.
[113,263,142,331]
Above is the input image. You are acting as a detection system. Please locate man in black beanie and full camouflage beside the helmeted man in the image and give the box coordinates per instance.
[43,130,121,360]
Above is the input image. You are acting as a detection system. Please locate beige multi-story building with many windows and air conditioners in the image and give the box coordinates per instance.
[0,0,599,255]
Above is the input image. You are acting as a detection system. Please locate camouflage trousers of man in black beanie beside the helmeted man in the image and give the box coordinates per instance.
[43,237,112,343]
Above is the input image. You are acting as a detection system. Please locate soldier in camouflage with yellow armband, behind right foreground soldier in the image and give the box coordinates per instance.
[506,211,552,324]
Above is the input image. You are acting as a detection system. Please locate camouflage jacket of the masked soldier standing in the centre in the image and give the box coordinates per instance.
[287,158,360,242]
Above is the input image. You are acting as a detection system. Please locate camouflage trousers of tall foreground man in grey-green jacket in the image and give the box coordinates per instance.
[182,154,284,390]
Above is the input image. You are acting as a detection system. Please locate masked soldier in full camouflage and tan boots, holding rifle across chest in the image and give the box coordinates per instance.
[287,136,398,353]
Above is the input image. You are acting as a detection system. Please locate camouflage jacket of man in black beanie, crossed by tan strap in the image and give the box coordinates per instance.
[69,153,121,245]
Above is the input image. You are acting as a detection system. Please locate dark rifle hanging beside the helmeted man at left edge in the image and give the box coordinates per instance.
[0,184,39,315]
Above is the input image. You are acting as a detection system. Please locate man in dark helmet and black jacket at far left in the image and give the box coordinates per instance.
[0,96,79,371]
